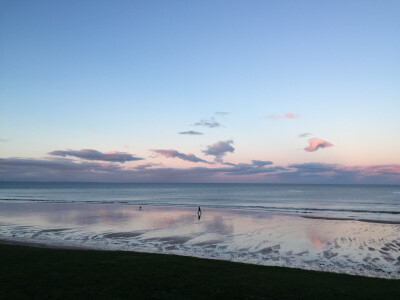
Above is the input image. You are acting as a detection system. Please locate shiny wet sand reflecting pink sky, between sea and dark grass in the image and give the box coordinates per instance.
[0,203,400,279]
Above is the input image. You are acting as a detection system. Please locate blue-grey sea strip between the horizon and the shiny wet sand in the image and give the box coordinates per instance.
[0,182,400,222]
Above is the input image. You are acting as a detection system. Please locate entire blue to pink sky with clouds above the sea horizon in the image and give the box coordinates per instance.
[0,0,400,184]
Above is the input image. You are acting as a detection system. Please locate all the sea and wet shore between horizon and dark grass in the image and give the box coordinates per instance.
[0,182,400,280]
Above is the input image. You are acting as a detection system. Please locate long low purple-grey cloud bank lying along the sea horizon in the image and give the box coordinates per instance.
[0,154,400,184]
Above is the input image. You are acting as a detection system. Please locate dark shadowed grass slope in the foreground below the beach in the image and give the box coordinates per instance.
[0,244,400,299]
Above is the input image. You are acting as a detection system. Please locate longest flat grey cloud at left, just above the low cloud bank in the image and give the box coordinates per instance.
[48,149,143,163]
